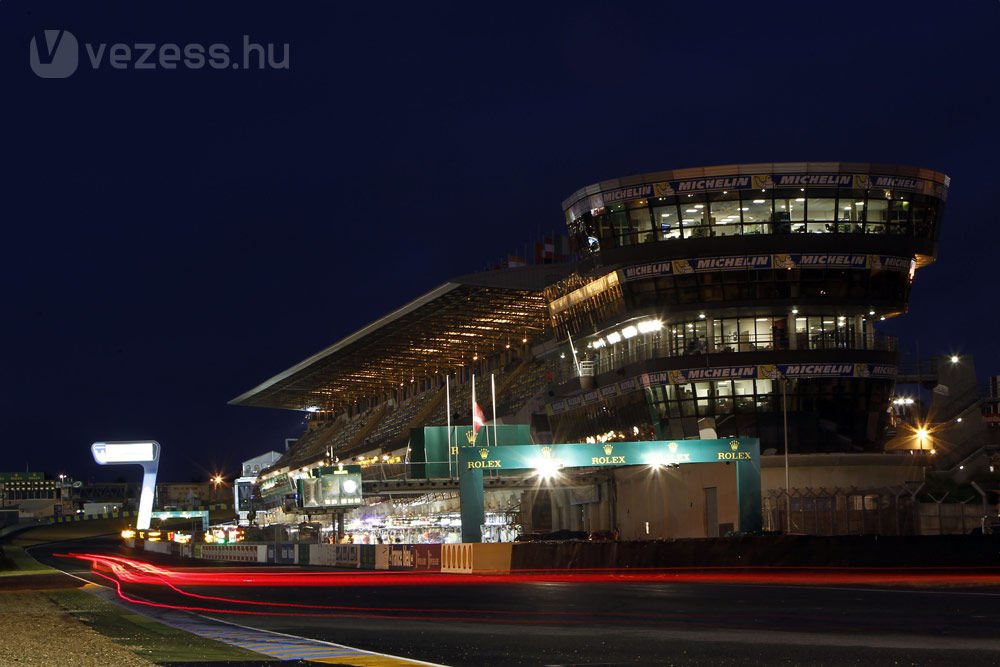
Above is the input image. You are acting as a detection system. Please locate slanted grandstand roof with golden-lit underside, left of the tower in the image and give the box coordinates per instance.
[229,264,570,410]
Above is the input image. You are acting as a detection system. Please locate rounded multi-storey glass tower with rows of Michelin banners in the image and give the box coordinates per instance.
[547,163,948,454]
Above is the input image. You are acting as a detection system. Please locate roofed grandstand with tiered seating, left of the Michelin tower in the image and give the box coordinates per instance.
[230,264,568,477]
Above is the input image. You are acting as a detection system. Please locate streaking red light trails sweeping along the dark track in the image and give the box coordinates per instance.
[59,553,1000,627]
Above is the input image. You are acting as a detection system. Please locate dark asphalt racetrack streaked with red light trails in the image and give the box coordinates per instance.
[23,543,1000,667]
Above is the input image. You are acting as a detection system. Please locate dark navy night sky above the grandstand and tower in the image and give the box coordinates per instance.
[0,0,1000,481]
